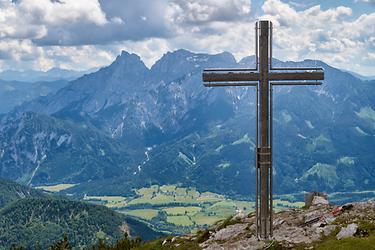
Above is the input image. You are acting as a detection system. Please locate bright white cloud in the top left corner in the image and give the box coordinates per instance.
[0,0,108,39]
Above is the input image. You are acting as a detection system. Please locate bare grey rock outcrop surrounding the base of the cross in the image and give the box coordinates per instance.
[161,201,375,250]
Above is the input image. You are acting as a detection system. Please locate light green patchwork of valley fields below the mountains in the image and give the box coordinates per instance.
[84,185,303,234]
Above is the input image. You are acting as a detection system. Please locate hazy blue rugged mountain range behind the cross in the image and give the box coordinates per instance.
[0,50,375,197]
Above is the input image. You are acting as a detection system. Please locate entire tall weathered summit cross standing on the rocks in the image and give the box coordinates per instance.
[203,21,324,239]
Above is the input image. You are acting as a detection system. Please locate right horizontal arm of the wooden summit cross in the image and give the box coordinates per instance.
[268,71,324,81]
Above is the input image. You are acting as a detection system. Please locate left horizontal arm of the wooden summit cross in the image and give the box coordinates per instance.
[202,71,259,82]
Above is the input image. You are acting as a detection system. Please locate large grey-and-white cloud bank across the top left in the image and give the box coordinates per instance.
[0,0,170,46]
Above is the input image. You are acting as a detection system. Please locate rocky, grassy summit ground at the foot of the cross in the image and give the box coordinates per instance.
[139,201,375,250]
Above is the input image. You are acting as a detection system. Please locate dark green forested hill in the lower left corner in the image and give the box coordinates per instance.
[0,179,162,249]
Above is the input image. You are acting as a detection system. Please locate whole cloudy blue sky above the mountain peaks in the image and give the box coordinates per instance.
[0,0,375,75]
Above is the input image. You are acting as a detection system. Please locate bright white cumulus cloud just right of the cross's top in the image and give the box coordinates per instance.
[262,0,375,73]
